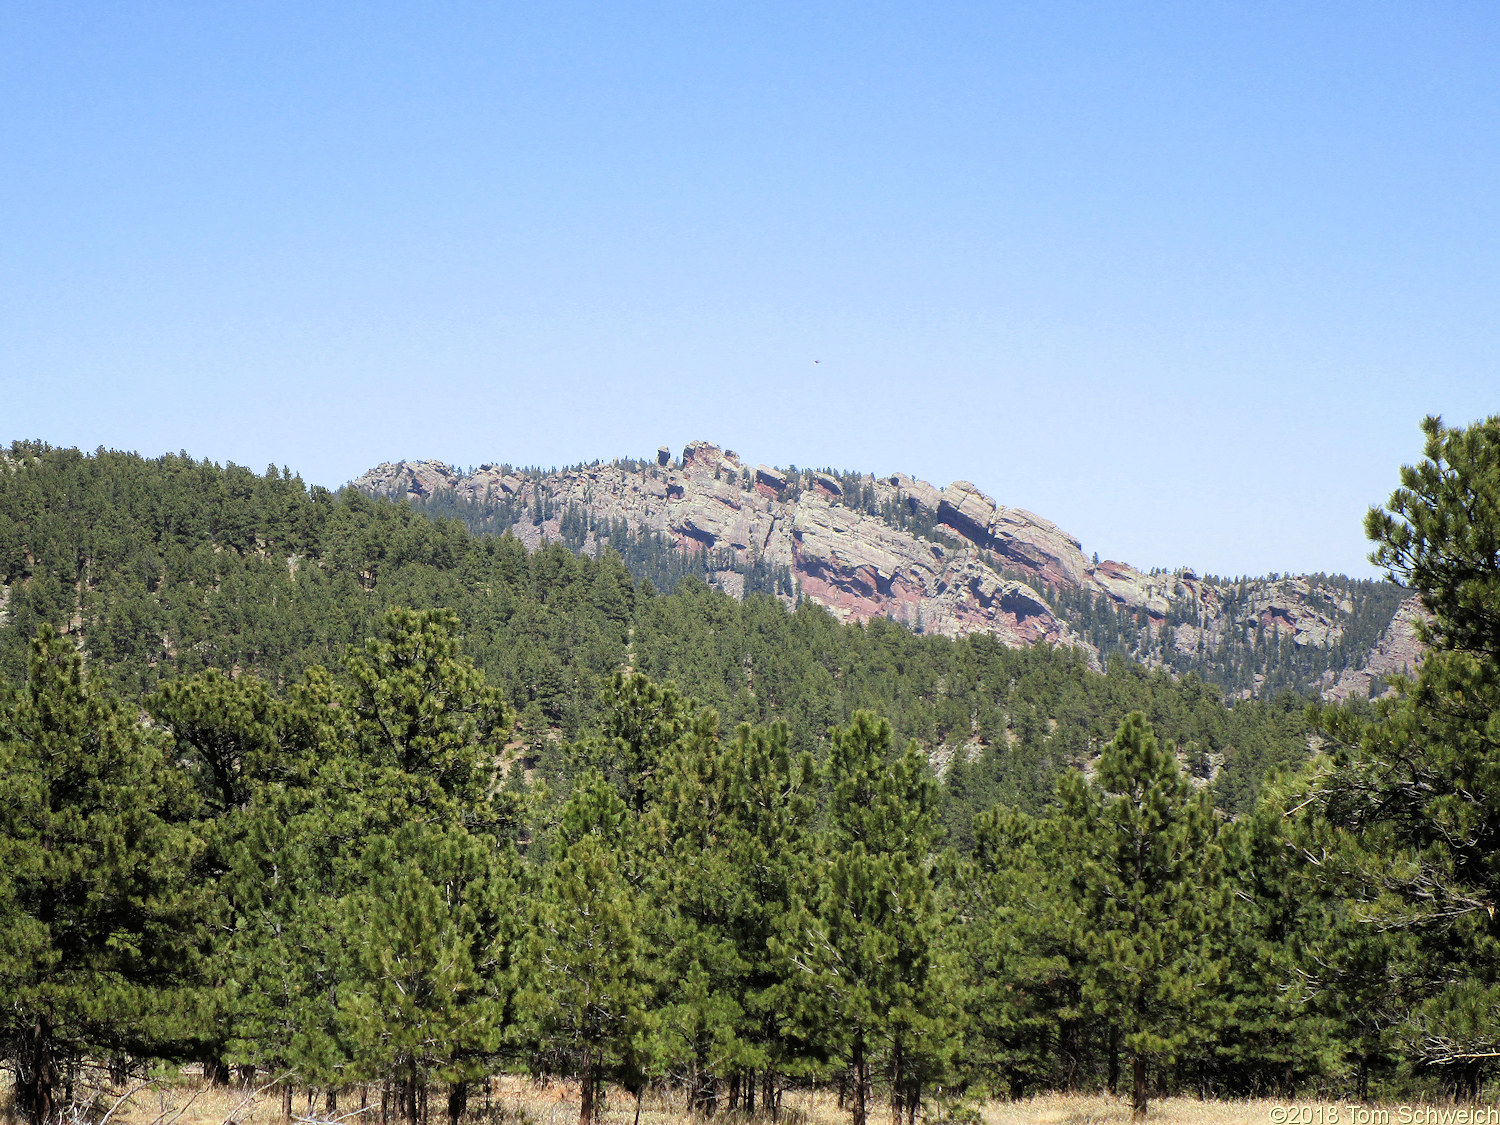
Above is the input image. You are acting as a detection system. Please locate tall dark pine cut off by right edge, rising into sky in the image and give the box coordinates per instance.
[1319,416,1500,1097]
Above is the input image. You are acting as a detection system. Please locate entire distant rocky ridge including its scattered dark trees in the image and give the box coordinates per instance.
[353,441,1412,695]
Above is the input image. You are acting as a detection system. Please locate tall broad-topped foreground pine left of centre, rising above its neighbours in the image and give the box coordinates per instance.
[333,609,521,1121]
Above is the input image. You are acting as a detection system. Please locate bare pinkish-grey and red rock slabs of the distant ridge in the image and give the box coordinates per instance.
[354,441,1421,684]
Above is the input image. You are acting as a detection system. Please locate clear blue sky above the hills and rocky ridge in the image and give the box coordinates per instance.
[0,0,1500,575]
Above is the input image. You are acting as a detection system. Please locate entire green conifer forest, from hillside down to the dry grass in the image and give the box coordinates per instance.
[0,417,1500,1125]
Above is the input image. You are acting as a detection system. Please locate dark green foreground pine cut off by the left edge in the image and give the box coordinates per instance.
[0,627,201,1124]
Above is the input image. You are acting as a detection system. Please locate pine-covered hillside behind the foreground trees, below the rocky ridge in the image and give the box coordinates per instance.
[0,446,1307,809]
